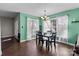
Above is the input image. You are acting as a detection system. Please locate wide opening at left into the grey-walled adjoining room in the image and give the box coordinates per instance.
[0,13,19,51]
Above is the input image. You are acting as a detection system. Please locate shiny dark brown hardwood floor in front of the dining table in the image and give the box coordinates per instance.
[2,40,73,56]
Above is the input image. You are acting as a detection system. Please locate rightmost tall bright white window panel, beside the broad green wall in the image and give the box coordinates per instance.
[56,15,68,42]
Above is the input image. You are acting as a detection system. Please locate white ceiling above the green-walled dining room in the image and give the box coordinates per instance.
[0,3,79,16]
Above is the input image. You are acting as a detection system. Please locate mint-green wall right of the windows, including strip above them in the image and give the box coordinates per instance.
[49,8,79,44]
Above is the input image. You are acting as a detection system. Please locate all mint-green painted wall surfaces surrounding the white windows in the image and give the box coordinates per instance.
[20,8,79,44]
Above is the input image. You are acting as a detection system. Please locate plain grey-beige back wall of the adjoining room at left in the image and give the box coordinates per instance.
[1,17,14,38]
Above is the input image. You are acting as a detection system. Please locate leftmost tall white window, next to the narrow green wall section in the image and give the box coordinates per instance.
[27,18,39,40]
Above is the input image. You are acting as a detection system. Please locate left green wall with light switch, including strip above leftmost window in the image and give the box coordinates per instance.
[20,13,41,41]
